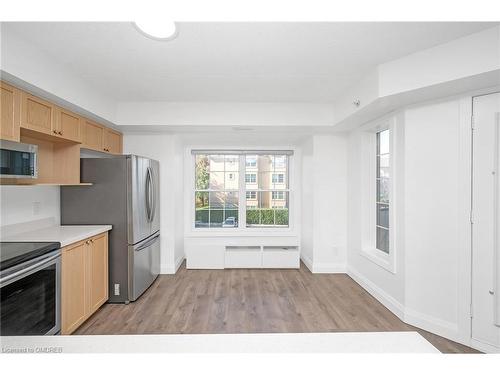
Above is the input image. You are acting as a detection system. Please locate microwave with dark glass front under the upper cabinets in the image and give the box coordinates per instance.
[0,140,38,178]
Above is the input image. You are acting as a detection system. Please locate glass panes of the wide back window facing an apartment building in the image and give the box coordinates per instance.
[194,151,290,228]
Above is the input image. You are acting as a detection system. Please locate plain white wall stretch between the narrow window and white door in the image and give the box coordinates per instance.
[405,99,470,339]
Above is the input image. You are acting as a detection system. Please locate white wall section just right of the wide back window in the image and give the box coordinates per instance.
[301,134,347,273]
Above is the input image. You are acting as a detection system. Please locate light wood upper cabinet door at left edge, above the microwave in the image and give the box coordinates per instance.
[0,82,21,142]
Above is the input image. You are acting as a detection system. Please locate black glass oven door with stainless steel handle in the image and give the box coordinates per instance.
[0,250,61,336]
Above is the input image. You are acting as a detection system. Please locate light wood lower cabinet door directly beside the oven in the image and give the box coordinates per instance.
[61,242,89,335]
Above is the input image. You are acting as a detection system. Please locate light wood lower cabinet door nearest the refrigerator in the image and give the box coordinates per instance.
[89,233,108,314]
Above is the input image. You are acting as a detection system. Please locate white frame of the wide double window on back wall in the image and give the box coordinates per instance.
[190,151,292,237]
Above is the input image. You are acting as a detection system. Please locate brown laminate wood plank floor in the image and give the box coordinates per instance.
[75,264,476,353]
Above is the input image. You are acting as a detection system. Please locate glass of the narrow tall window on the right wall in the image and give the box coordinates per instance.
[376,129,391,254]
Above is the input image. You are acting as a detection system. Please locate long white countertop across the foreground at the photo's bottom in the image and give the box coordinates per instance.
[2,332,439,353]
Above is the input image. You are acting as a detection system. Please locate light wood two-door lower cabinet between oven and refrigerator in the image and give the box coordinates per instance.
[61,232,108,335]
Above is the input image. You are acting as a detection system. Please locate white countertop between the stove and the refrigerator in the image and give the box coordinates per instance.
[1,225,112,247]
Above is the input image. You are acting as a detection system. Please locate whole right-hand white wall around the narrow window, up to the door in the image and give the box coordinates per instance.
[348,95,471,344]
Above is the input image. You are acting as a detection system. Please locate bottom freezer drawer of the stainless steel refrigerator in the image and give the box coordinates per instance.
[129,232,160,301]
